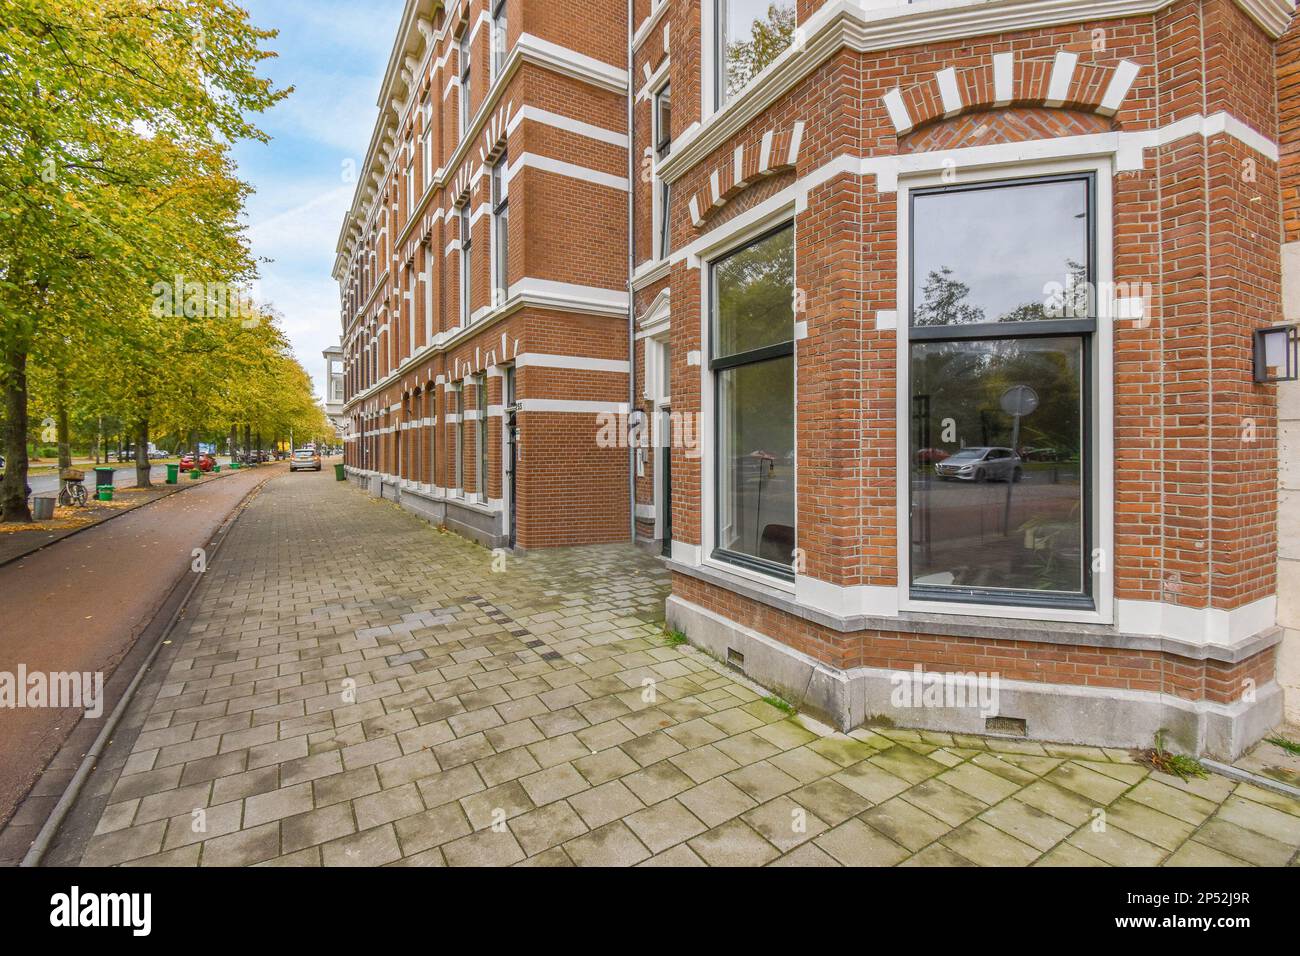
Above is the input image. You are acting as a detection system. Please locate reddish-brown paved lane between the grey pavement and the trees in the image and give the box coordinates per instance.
[0,466,287,823]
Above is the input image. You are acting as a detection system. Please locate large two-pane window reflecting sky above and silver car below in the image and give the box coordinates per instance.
[907,176,1096,607]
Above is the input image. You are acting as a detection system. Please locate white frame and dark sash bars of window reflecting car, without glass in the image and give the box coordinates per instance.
[896,167,1114,624]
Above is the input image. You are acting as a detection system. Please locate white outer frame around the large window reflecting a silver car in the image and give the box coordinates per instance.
[896,156,1115,624]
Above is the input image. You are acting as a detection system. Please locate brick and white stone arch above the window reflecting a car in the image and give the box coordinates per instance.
[883,49,1141,137]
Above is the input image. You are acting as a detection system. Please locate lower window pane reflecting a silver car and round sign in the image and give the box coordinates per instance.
[910,337,1088,594]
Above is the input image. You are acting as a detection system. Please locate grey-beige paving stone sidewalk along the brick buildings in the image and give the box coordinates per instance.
[71,475,1300,866]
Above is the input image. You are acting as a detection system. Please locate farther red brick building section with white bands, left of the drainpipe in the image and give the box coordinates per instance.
[334,0,631,548]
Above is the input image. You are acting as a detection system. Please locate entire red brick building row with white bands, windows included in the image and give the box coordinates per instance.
[338,0,1292,756]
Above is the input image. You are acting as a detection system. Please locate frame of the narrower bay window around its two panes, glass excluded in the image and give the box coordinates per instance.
[703,219,798,583]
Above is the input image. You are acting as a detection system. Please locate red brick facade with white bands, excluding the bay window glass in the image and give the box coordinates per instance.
[337,0,1300,756]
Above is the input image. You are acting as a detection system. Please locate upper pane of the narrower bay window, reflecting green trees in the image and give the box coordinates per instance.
[714,226,794,359]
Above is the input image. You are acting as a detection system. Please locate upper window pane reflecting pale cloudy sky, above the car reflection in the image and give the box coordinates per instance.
[911,178,1093,328]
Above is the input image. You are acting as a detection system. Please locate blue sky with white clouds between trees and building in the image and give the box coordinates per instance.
[235,0,403,397]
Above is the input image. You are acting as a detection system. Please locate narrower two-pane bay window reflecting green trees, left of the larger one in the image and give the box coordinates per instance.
[710,225,794,578]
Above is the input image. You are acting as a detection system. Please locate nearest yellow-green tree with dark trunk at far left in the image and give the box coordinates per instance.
[0,0,287,520]
